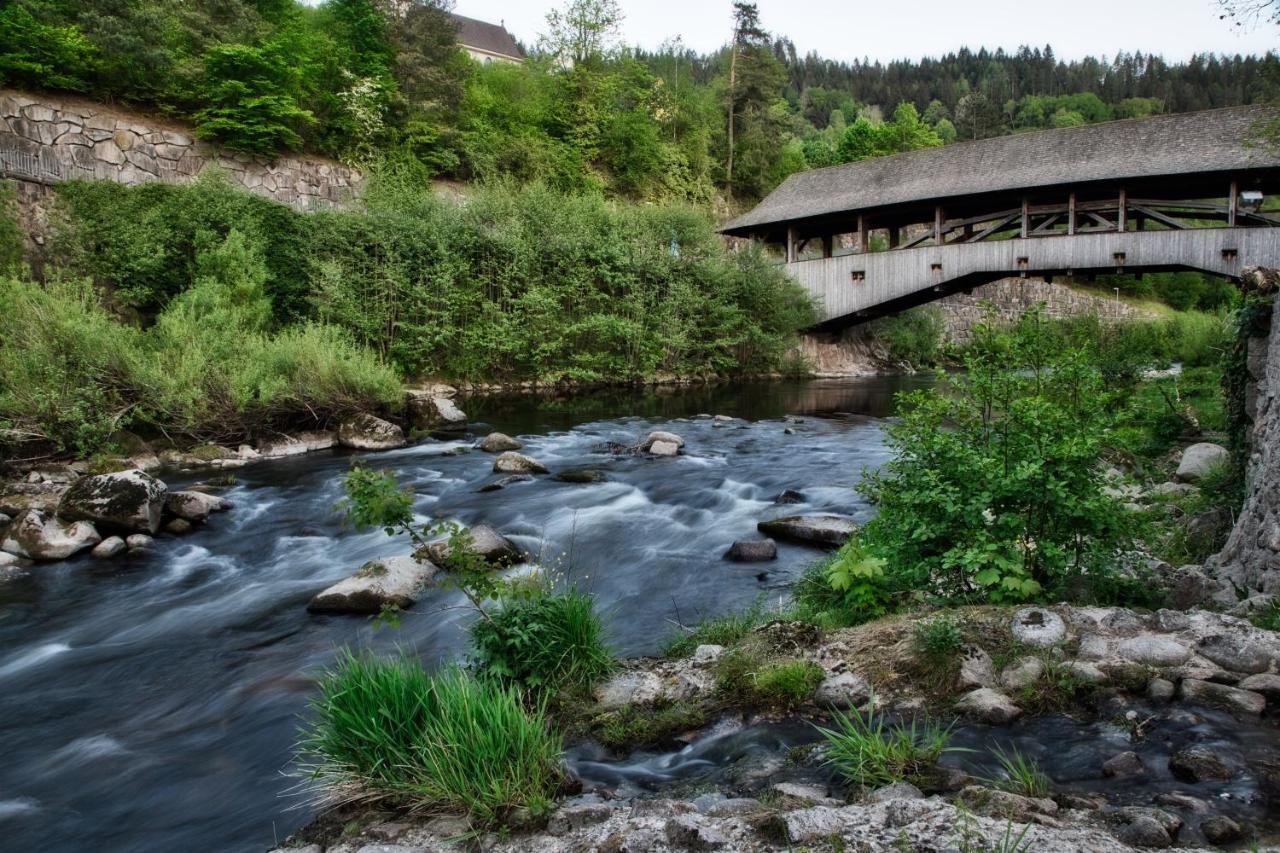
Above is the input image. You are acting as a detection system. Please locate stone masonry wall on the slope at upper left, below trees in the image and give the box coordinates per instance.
[0,90,361,210]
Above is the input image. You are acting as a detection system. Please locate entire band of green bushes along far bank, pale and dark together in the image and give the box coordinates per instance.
[0,173,812,456]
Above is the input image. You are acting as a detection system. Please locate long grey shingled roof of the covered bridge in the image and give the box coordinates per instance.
[721,106,1280,234]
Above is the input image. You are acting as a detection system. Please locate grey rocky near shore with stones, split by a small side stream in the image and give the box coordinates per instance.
[280,596,1280,853]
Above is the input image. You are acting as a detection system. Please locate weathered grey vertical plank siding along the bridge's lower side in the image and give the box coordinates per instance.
[787,228,1280,325]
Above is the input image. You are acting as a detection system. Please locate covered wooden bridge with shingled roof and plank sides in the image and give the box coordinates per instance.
[722,100,1280,327]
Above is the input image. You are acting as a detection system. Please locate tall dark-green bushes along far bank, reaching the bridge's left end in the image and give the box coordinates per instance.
[47,175,812,380]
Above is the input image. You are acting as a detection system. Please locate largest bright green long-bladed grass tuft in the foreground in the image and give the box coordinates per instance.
[300,652,561,824]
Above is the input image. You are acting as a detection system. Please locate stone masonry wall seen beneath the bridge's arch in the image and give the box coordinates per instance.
[936,272,1144,343]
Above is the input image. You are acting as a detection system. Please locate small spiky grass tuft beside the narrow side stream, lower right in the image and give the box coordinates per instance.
[818,702,955,788]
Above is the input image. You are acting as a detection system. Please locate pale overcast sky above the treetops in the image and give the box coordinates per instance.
[454,0,1280,60]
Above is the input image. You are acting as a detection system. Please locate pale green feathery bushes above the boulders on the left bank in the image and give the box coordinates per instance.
[0,266,401,456]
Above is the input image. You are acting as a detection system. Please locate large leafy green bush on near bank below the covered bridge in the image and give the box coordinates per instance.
[859,311,1129,602]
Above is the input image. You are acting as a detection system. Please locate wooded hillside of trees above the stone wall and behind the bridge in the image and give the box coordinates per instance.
[0,0,1280,199]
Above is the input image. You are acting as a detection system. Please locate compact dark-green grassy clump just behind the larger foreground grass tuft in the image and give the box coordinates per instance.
[471,587,613,692]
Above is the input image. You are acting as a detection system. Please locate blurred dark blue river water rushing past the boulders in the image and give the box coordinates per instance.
[0,379,919,853]
